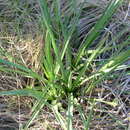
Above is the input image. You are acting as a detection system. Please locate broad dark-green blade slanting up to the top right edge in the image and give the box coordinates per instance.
[75,0,123,65]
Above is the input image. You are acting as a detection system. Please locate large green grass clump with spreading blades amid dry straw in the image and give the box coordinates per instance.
[0,0,130,130]
